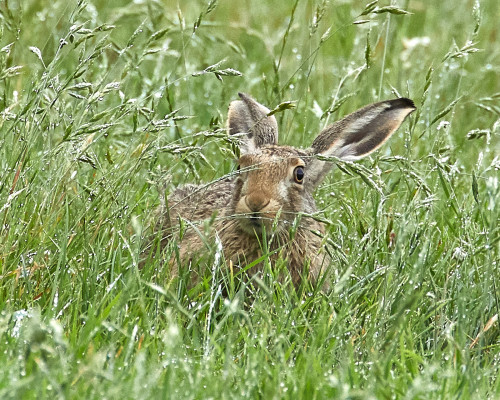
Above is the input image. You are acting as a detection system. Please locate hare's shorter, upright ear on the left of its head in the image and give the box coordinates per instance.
[227,93,278,154]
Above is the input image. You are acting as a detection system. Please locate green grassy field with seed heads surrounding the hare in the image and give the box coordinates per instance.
[0,0,500,399]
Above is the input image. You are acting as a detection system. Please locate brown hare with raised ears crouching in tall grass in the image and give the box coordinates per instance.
[155,93,415,286]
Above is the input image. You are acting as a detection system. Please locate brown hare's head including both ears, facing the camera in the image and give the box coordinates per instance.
[228,93,415,233]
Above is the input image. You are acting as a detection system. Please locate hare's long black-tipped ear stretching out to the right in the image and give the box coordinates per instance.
[308,98,415,184]
